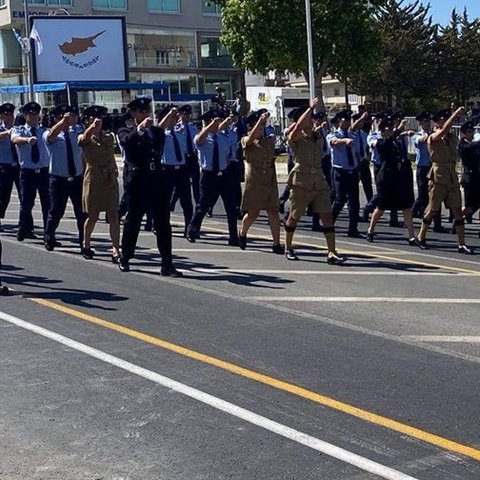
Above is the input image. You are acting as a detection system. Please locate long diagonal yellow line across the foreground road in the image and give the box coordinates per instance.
[30,298,480,461]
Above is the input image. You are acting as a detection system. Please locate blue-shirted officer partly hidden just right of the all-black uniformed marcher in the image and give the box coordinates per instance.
[158,106,193,236]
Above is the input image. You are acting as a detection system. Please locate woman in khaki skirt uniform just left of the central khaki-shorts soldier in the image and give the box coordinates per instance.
[239,111,284,254]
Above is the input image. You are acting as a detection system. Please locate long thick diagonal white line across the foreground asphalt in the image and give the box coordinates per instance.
[0,312,418,480]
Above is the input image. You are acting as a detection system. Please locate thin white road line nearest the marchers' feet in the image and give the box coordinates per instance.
[191,270,472,277]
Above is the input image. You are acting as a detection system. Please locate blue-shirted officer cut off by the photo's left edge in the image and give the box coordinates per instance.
[0,103,20,232]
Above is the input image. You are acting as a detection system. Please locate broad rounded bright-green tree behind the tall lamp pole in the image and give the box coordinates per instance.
[212,0,386,107]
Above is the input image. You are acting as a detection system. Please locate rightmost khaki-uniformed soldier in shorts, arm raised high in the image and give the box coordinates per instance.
[418,107,473,254]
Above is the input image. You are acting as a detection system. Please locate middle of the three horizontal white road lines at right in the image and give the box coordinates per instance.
[248,296,480,305]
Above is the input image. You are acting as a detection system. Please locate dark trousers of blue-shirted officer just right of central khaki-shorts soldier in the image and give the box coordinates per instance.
[332,167,360,232]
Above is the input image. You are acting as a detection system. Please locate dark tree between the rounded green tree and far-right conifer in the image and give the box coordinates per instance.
[351,0,437,106]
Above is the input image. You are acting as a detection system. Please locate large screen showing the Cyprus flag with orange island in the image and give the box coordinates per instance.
[31,17,127,83]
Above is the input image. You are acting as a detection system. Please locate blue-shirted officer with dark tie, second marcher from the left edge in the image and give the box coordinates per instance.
[10,102,50,242]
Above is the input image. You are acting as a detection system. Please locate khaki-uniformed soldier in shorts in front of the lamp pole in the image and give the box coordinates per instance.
[285,99,345,264]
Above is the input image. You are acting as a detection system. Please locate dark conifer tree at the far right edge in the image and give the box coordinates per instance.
[434,10,480,105]
